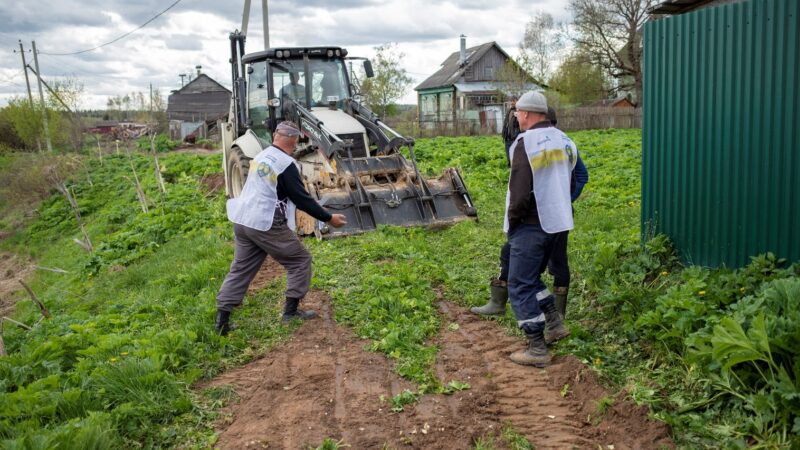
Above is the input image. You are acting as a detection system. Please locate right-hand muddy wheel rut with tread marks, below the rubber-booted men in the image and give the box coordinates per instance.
[436,301,672,450]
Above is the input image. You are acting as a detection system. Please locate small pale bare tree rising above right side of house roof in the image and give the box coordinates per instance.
[519,11,564,84]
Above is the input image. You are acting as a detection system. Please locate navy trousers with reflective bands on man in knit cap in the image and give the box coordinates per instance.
[508,224,556,334]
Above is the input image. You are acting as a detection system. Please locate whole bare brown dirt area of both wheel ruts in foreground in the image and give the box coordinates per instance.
[209,292,670,449]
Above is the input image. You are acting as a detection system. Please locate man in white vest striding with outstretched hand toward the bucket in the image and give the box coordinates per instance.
[215,122,347,336]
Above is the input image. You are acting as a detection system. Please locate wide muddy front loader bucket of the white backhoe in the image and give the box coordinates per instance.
[298,153,477,238]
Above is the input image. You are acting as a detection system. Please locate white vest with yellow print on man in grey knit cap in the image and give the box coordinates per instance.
[503,127,578,234]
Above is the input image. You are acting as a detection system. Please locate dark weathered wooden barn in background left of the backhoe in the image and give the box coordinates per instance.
[167,74,231,121]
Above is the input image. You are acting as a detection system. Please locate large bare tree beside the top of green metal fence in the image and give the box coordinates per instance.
[570,0,658,102]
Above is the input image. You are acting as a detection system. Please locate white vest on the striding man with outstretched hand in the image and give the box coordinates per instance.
[226,146,297,231]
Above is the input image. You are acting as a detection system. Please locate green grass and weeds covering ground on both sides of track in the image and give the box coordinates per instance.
[0,130,800,449]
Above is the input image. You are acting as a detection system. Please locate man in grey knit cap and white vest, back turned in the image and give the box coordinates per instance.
[503,92,578,367]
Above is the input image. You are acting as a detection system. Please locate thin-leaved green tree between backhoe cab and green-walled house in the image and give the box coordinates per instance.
[361,43,413,117]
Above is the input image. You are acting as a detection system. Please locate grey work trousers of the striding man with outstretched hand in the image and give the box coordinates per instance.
[217,211,311,311]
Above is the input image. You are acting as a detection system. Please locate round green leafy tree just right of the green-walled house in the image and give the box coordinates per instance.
[549,51,609,105]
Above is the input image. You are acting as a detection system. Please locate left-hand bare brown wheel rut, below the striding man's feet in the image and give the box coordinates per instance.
[204,292,490,449]
